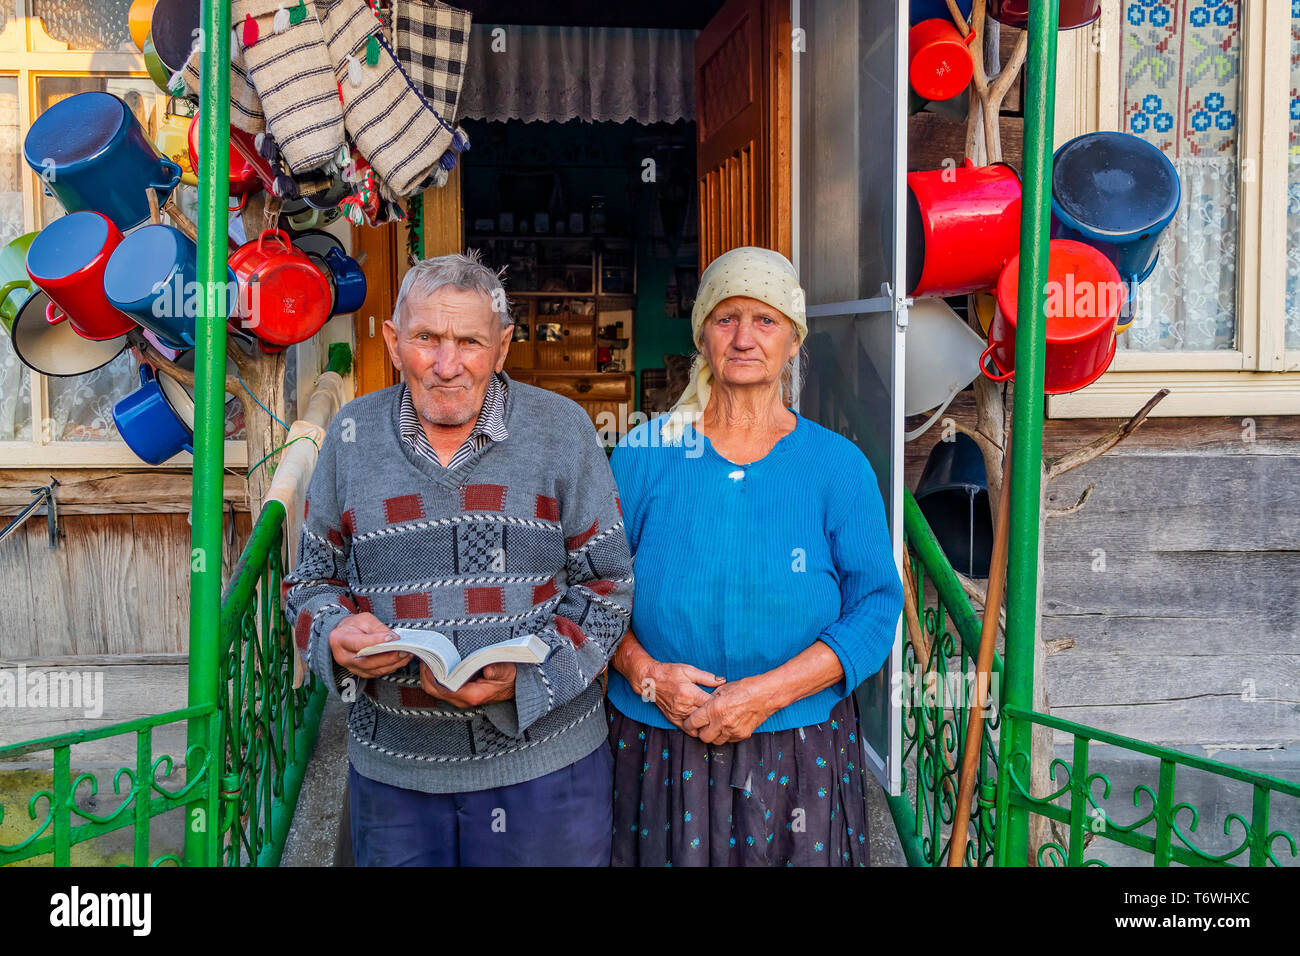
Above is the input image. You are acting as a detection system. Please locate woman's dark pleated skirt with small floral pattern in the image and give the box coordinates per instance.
[608,695,871,866]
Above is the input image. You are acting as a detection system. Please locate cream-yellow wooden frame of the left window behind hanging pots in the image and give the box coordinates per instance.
[0,0,253,471]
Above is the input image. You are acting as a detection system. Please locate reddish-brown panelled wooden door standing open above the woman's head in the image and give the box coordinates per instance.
[696,0,792,272]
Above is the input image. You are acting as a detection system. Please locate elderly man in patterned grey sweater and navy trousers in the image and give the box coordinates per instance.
[286,255,632,866]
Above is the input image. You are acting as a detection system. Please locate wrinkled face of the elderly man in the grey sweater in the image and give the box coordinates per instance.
[384,286,514,427]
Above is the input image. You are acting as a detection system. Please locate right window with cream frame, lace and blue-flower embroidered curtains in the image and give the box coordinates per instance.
[1048,0,1300,416]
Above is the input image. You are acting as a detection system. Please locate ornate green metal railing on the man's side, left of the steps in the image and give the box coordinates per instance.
[0,501,325,866]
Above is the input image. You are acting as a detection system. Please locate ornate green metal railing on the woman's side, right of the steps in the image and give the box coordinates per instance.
[888,492,1300,866]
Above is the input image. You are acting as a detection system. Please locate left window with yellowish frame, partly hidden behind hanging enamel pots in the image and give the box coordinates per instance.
[0,0,296,467]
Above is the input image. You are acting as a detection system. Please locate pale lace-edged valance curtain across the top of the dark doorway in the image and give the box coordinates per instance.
[456,23,696,124]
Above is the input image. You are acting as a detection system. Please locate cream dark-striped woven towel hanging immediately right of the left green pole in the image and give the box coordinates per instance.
[230,0,343,173]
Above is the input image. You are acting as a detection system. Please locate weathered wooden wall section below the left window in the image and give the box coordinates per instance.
[0,470,250,662]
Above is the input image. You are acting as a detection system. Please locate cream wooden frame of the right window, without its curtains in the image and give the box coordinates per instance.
[1047,0,1300,418]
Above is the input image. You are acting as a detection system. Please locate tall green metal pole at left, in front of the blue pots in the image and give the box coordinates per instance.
[185,0,230,866]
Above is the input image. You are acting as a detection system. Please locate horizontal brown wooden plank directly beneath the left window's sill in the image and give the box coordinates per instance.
[0,468,248,520]
